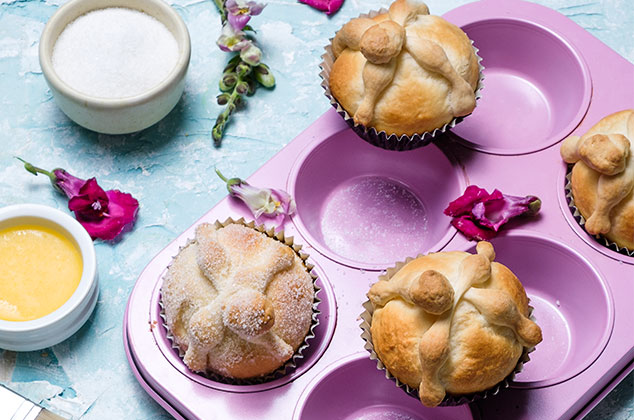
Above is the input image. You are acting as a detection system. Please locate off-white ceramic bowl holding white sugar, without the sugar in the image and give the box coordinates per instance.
[39,0,191,134]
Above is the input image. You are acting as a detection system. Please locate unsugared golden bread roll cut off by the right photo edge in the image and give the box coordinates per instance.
[560,109,634,250]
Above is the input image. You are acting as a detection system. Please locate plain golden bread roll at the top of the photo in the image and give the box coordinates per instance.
[329,0,479,136]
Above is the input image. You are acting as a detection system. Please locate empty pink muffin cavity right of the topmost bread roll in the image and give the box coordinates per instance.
[452,18,591,155]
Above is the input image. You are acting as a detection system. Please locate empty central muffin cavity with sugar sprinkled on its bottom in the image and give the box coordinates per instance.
[289,130,465,269]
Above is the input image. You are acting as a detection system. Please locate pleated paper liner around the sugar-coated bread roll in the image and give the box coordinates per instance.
[159,218,321,385]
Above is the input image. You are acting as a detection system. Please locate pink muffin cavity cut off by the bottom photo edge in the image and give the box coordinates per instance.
[293,353,473,420]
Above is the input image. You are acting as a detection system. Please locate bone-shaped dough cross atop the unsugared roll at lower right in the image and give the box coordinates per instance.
[368,242,542,406]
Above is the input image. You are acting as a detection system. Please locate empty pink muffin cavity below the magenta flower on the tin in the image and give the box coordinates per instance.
[471,231,614,388]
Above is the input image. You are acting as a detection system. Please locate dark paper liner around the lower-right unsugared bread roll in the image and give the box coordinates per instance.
[360,255,535,407]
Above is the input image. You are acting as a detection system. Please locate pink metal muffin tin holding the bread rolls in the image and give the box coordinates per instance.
[124,0,634,420]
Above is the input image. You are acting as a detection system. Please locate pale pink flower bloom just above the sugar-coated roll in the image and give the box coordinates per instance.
[216,169,296,226]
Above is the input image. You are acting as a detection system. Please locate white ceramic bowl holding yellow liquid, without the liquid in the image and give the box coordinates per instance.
[0,204,99,351]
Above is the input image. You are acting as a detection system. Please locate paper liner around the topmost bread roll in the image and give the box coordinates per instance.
[319,8,484,151]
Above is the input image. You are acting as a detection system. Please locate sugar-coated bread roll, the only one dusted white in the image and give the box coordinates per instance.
[161,223,315,379]
